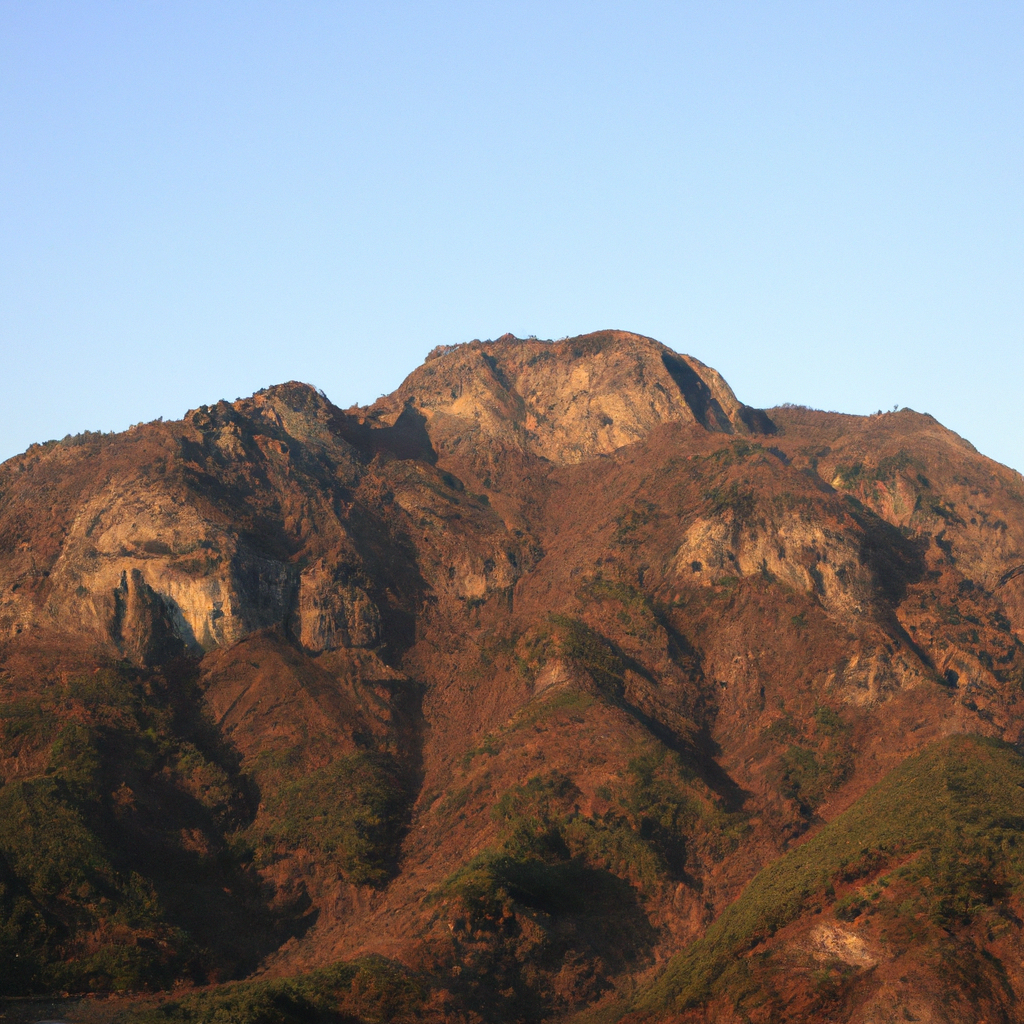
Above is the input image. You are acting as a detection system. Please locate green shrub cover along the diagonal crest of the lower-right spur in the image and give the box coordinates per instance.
[638,736,1024,1010]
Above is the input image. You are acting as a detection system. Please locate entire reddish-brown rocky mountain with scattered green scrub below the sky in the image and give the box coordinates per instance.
[0,331,1024,1024]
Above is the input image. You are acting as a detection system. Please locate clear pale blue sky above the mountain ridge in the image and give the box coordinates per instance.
[0,0,1024,469]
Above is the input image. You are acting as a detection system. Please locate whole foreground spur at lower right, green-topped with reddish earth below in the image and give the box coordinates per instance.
[631,737,1024,1022]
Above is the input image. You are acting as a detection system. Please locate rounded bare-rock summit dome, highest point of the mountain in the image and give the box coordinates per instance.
[368,331,775,463]
